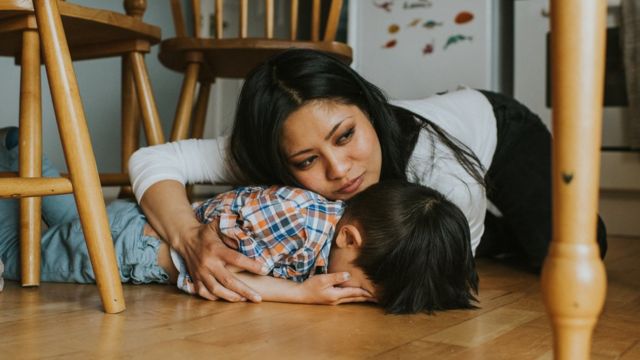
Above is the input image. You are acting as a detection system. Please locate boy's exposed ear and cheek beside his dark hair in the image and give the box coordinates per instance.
[328,224,376,298]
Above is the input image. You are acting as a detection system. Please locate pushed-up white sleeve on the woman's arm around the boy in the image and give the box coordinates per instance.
[129,136,232,202]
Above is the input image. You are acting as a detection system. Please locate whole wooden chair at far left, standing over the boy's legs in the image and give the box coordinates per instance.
[0,0,164,313]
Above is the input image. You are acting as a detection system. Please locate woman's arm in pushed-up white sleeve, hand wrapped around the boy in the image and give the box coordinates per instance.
[129,140,262,301]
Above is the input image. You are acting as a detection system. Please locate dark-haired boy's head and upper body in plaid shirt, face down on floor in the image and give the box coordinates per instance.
[172,181,478,313]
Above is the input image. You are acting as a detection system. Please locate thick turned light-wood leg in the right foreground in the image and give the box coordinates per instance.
[541,0,607,359]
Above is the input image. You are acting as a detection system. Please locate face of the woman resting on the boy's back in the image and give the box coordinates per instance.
[281,101,382,200]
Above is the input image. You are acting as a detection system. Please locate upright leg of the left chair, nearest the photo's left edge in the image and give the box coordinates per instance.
[19,30,42,286]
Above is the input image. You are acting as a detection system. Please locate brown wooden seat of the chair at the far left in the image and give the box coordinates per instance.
[0,0,160,63]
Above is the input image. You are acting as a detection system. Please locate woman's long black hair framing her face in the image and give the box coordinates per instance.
[230,49,484,186]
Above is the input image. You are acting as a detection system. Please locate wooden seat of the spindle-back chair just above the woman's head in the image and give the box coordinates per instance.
[158,38,352,81]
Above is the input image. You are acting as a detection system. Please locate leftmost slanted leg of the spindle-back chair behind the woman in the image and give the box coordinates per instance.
[171,62,200,141]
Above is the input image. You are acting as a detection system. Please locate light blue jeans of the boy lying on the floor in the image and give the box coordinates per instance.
[0,147,168,283]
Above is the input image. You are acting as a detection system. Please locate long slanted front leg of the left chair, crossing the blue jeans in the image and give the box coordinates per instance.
[33,0,125,313]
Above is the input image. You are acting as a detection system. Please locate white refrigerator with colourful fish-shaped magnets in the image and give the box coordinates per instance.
[348,0,504,99]
